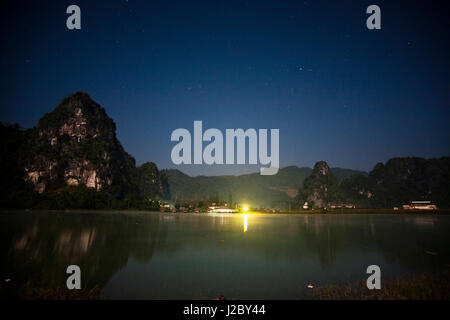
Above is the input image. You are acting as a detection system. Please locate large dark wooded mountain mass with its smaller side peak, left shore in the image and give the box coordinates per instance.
[0,92,168,209]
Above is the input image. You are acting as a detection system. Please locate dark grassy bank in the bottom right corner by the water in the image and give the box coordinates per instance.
[312,271,450,300]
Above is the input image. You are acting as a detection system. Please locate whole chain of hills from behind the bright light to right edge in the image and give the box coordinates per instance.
[163,157,450,209]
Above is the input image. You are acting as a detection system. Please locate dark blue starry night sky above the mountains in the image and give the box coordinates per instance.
[0,0,450,175]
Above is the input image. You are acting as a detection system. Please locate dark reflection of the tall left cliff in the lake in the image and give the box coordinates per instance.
[1,213,167,288]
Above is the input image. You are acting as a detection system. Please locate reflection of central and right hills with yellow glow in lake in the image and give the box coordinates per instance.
[157,214,450,269]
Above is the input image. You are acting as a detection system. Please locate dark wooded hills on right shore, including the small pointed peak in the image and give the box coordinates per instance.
[299,157,450,208]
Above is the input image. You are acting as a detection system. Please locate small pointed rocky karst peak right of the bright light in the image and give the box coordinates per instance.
[299,161,342,208]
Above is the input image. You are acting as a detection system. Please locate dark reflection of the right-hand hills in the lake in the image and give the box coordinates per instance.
[298,215,450,270]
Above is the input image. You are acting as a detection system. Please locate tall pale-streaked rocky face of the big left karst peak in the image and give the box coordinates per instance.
[23,92,135,193]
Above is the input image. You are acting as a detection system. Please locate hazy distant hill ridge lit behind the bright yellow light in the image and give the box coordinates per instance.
[162,166,367,206]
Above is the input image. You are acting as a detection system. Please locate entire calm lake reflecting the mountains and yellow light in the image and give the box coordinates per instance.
[0,211,450,299]
